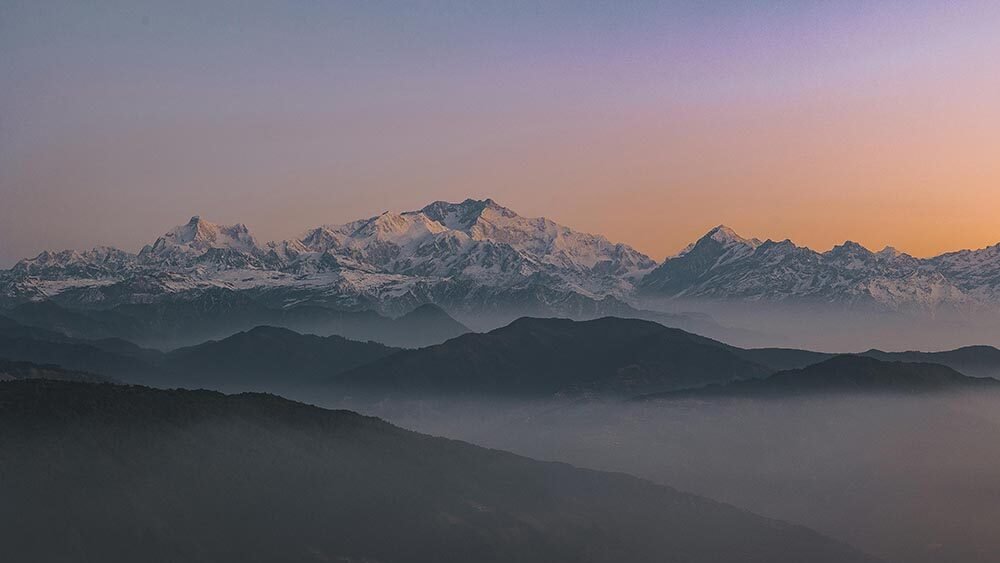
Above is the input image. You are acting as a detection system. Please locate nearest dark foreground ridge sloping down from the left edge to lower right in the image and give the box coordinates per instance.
[0,381,868,563]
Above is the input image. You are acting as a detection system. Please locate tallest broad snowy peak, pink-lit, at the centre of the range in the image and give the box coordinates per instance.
[277,199,656,286]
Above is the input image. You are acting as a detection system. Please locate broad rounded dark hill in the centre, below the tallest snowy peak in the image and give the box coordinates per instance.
[334,317,772,397]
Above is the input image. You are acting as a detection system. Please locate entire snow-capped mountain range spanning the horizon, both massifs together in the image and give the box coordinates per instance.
[7,207,1000,318]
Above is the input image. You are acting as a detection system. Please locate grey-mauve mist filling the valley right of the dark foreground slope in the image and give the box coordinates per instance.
[308,390,1000,563]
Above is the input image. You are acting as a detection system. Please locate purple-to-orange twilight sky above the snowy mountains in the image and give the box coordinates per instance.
[0,0,1000,267]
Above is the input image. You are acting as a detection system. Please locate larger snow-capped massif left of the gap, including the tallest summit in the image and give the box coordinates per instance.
[0,199,656,313]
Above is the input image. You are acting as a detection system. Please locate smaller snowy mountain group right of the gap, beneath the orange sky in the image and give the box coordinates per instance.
[640,226,976,309]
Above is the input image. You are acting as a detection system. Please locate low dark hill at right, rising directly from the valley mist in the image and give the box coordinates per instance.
[643,355,1000,399]
